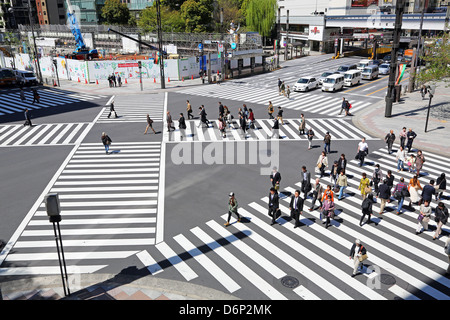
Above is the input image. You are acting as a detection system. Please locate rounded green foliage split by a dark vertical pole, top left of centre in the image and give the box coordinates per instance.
[138,6,185,32]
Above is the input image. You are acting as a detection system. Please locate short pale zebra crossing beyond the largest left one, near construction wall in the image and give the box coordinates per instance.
[97,94,165,123]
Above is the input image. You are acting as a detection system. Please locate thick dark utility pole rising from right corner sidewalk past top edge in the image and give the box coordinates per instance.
[384,0,405,118]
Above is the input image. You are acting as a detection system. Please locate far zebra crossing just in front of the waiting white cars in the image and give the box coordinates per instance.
[177,83,373,117]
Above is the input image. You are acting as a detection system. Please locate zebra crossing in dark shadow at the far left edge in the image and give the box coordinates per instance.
[0,87,107,116]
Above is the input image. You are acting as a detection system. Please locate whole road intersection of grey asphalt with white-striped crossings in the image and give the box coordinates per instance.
[0,55,450,300]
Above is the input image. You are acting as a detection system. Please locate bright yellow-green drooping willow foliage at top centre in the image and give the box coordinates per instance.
[244,0,277,37]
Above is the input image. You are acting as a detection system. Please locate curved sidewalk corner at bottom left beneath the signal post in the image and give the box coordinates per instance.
[0,274,238,301]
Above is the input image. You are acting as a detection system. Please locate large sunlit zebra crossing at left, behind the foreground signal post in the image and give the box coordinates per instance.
[0,142,161,275]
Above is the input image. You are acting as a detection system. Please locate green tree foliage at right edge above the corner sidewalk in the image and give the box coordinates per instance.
[417,32,450,83]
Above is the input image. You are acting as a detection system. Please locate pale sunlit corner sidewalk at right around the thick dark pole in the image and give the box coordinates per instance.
[352,82,450,157]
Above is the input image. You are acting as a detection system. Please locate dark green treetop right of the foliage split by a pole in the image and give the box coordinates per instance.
[180,0,214,32]
